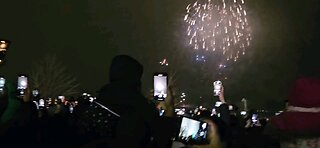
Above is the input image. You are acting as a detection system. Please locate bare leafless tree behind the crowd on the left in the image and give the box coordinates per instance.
[30,55,80,98]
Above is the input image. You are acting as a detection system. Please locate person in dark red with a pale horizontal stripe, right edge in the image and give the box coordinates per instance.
[266,77,320,148]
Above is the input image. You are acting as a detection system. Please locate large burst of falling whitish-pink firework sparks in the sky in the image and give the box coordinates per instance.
[184,0,251,61]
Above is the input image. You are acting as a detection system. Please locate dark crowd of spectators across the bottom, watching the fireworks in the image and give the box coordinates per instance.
[0,55,320,148]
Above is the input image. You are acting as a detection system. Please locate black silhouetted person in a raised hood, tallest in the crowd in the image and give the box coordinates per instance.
[98,55,178,148]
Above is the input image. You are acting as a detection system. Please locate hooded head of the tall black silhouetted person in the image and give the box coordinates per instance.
[109,55,143,87]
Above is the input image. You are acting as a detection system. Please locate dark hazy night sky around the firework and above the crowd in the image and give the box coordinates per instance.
[0,0,319,108]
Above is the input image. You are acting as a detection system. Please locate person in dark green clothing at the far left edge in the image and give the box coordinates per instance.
[0,82,37,147]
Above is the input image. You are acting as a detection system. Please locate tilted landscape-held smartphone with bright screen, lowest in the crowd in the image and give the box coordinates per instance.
[176,117,209,145]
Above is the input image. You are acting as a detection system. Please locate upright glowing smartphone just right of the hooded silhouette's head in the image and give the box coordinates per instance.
[153,73,168,101]
